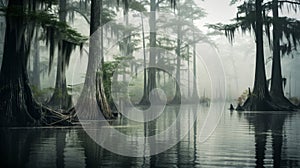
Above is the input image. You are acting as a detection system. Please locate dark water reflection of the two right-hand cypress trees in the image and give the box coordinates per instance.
[245,113,296,167]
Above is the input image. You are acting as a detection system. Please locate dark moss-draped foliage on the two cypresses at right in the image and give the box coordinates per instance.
[208,1,300,47]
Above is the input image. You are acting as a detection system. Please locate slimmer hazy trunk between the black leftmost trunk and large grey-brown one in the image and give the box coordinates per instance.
[48,0,72,109]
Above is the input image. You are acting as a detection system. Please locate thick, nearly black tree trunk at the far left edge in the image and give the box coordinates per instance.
[0,0,41,126]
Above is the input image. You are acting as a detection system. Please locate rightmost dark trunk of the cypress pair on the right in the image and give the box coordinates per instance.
[270,0,296,108]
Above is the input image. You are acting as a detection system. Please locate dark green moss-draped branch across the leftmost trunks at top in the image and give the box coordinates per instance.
[1,0,87,72]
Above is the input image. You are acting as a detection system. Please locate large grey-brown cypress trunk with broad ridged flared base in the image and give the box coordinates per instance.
[76,0,112,120]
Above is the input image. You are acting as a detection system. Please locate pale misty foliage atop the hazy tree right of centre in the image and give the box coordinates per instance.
[157,0,213,60]
